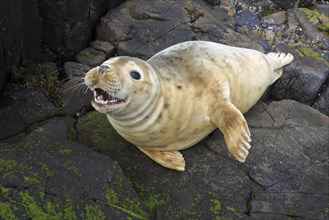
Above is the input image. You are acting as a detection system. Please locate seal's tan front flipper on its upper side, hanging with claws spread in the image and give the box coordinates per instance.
[210,102,251,162]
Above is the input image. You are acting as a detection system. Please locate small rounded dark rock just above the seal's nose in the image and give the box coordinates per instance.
[75,48,106,68]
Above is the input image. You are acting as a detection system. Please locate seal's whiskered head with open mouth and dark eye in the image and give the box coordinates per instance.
[85,57,159,116]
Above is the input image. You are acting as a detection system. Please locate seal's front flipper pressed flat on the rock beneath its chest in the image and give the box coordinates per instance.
[138,147,185,171]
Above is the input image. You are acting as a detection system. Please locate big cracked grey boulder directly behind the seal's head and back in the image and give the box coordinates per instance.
[96,0,263,59]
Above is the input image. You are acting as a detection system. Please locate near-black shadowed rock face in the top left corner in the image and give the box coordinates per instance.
[0,0,124,93]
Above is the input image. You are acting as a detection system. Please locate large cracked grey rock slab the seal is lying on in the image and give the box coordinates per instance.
[77,101,329,219]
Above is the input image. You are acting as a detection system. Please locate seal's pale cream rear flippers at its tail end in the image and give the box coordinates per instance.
[266,52,294,84]
